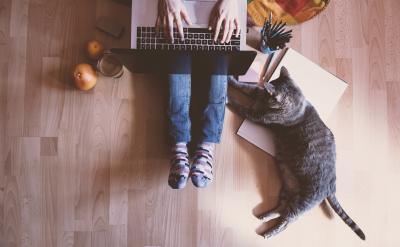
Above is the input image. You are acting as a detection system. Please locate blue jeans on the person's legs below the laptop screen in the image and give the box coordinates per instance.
[168,74,228,143]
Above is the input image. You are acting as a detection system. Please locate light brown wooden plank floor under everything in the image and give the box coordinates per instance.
[0,0,400,247]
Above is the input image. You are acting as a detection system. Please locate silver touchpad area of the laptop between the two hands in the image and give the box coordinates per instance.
[185,0,217,27]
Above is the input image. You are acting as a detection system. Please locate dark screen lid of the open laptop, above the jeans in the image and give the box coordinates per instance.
[111,49,257,75]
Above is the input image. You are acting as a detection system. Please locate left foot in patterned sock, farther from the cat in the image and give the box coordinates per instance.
[168,142,190,189]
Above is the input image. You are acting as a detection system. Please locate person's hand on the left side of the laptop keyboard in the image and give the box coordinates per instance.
[156,0,192,42]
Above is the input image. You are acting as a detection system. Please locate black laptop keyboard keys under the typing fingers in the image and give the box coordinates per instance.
[137,27,240,51]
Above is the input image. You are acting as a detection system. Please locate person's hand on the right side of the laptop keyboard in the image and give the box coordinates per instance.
[209,0,240,43]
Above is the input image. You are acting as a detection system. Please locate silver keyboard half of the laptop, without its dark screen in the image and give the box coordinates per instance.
[131,0,247,51]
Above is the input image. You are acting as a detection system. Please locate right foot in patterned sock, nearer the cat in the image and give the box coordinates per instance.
[190,143,214,188]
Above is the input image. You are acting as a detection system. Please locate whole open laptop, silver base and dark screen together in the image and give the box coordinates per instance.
[111,0,256,75]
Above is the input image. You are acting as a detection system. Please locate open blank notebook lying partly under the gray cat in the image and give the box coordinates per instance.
[237,48,347,156]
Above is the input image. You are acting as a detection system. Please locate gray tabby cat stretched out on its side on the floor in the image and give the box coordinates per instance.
[228,67,365,240]
